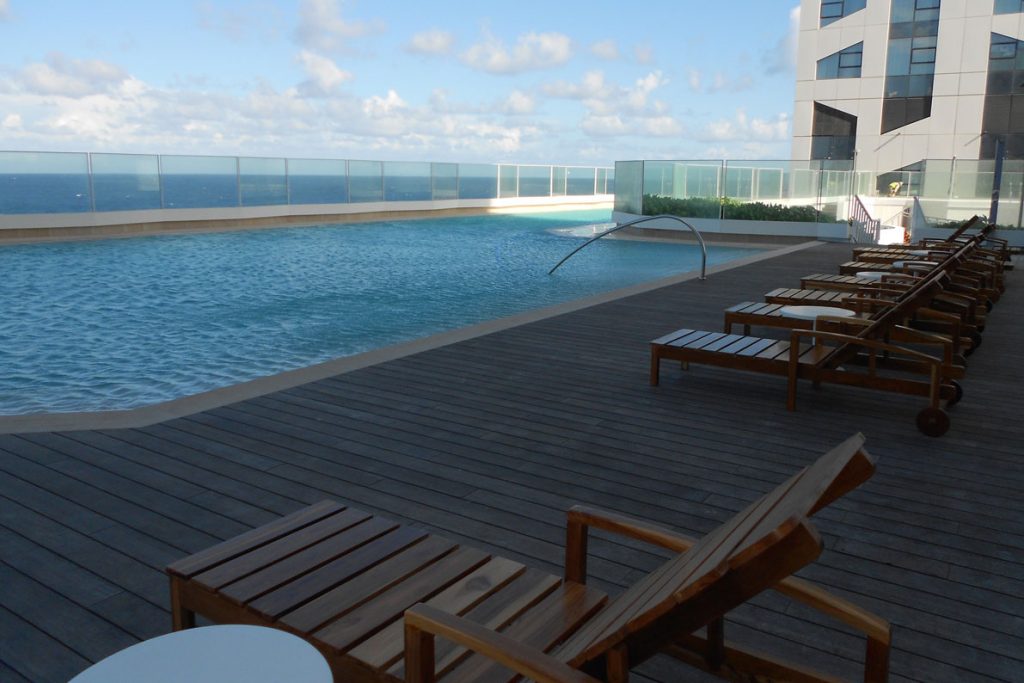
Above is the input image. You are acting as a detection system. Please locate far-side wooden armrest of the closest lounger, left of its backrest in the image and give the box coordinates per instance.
[565,505,696,584]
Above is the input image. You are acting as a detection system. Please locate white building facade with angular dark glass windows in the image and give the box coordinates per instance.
[793,0,1024,188]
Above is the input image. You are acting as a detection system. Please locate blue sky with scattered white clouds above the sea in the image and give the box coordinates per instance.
[0,0,799,165]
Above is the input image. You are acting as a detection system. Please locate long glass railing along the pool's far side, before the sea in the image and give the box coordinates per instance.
[0,152,615,214]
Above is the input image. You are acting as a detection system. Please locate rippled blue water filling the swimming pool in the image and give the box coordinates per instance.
[0,211,756,415]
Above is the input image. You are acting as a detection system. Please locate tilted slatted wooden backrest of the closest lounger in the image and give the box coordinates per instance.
[558,434,874,667]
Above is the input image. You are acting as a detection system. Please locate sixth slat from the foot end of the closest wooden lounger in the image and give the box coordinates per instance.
[313,541,490,652]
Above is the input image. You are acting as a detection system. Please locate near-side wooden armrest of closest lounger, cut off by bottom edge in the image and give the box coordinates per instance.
[406,604,598,683]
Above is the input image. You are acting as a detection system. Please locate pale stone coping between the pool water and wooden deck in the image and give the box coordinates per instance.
[0,240,826,434]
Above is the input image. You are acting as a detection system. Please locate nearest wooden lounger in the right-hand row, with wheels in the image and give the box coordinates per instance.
[650,273,963,436]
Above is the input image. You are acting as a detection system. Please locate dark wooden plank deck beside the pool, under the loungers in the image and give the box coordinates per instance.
[0,241,1024,683]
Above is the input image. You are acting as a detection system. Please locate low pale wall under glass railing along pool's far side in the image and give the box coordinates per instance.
[0,195,613,242]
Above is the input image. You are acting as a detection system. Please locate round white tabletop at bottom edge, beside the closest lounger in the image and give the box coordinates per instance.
[70,625,333,683]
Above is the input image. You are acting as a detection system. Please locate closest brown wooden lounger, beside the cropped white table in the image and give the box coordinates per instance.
[168,434,890,683]
